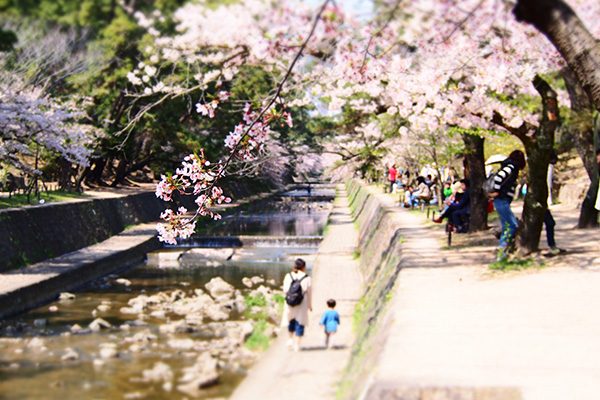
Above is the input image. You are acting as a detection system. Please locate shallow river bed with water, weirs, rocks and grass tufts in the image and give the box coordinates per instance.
[0,185,335,400]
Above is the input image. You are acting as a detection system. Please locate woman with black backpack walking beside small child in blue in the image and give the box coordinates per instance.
[282,258,312,351]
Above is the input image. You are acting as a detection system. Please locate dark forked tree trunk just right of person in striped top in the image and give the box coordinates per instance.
[492,76,559,254]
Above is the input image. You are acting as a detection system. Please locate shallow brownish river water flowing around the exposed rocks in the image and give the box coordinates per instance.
[0,188,330,400]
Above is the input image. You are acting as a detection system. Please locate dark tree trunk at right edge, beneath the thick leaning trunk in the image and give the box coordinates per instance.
[562,68,600,228]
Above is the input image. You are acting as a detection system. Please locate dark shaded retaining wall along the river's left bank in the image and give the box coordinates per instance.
[0,182,269,272]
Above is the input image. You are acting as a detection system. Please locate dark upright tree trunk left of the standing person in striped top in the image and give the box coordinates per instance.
[462,133,488,232]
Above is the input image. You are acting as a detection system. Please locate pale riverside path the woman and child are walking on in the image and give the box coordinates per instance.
[232,185,362,400]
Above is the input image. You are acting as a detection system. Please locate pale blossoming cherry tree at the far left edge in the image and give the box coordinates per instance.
[0,24,100,191]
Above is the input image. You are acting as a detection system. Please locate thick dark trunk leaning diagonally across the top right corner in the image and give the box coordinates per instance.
[513,0,600,110]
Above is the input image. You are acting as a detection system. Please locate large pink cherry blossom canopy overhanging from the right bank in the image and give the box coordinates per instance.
[124,0,596,250]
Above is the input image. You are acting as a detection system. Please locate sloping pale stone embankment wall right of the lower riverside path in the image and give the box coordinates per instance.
[340,180,402,399]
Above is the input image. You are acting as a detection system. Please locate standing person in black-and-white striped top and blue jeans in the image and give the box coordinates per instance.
[490,150,526,261]
